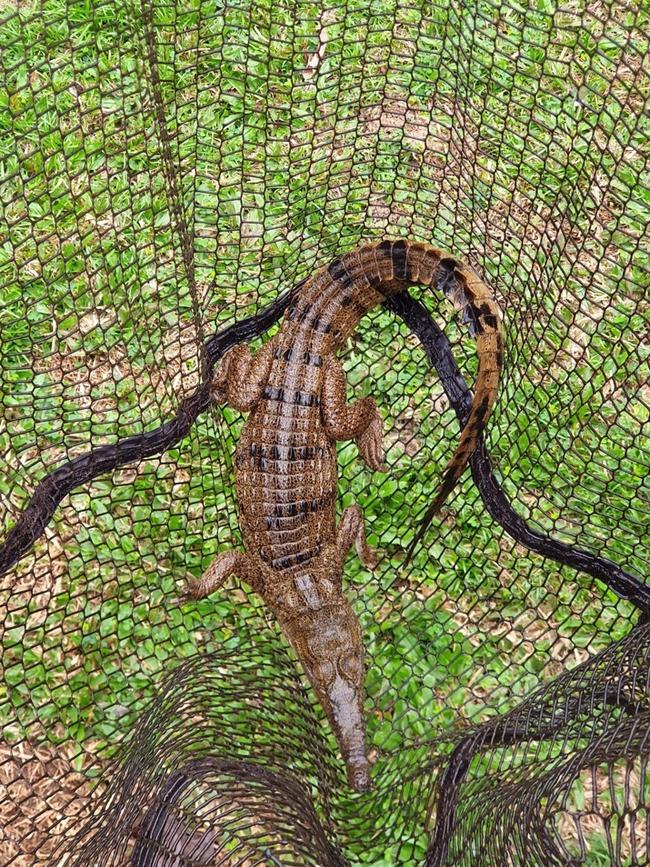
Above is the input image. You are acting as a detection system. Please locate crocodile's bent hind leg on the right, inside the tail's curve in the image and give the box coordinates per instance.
[321,356,386,470]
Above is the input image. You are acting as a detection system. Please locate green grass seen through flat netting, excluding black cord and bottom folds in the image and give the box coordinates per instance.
[0,0,649,863]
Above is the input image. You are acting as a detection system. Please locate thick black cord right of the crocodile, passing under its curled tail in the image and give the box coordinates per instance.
[385,292,650,619]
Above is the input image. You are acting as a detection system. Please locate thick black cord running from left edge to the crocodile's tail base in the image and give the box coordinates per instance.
[0,281,304,575]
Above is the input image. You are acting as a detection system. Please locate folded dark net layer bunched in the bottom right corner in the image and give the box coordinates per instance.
[426,626,650,867]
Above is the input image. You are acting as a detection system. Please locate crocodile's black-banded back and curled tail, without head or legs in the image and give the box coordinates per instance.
[236,241,503,571]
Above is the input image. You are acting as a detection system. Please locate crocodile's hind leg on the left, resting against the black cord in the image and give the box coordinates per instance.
[210,342,273,412]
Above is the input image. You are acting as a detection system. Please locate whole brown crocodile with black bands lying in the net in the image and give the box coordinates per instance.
[182,241,502,791]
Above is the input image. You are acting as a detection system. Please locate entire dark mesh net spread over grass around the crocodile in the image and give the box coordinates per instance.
[0,0,650,867]
